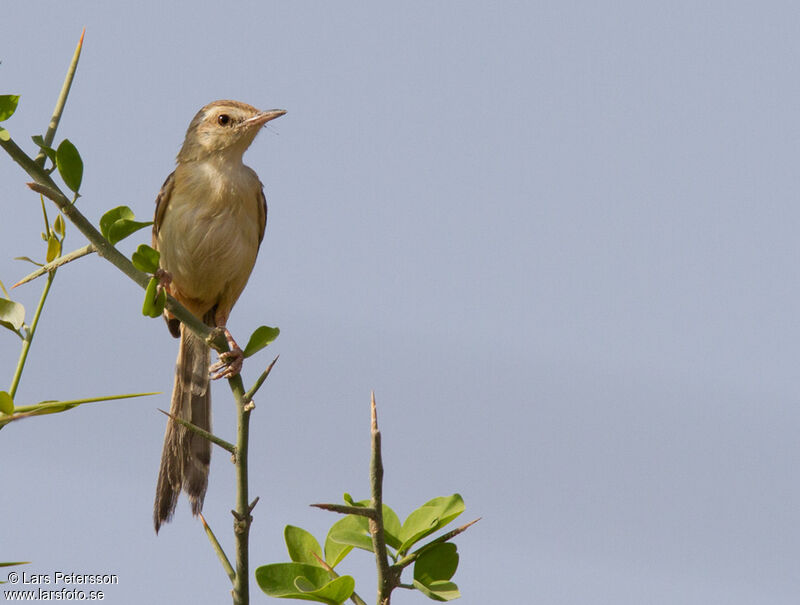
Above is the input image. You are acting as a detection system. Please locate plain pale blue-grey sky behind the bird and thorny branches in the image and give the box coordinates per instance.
[0,0,800,605]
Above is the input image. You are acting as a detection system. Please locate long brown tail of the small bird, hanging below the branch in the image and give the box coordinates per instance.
[153,326,211,533]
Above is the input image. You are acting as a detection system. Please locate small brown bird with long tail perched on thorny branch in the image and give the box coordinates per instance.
[153,101,286,533]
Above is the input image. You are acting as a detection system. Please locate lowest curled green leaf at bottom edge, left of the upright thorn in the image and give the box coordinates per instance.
[256,563,355,605]
